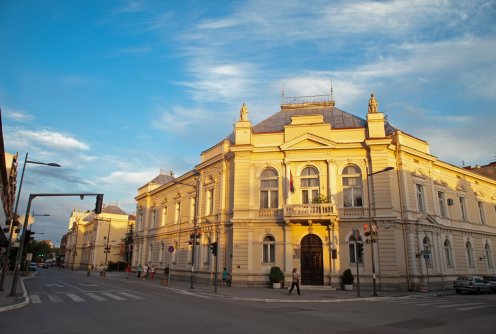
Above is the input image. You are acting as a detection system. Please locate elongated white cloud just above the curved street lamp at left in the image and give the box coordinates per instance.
[17,129,89,151]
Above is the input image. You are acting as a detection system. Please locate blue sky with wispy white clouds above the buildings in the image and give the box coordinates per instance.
[0,0,496,244]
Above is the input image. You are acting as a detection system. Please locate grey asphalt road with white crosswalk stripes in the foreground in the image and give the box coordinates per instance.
[0,269,496,334]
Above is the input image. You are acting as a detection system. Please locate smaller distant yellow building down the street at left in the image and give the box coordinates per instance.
[61,205,134,270]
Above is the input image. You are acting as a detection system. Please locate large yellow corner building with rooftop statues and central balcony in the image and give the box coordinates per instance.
[133,95,496,290]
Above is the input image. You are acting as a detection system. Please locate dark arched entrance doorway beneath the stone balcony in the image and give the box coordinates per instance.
[300,234,324,285]
